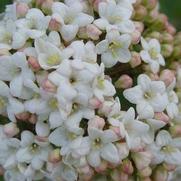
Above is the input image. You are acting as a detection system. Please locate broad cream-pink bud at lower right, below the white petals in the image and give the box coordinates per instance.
[132,151,152,170]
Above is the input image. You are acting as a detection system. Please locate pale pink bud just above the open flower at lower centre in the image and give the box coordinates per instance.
[88,116,105,129]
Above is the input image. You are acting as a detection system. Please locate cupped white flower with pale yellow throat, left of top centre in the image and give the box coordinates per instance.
[35,39,72,70]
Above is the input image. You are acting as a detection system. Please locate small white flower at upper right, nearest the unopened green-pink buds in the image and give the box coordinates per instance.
[140,38,165,73]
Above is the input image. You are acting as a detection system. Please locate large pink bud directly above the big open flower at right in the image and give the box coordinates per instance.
[160,69,175,87]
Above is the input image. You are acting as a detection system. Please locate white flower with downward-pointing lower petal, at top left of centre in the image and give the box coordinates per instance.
[52,2,93,41]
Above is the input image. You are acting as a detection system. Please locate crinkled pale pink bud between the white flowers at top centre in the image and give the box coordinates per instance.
[87,24,102,40]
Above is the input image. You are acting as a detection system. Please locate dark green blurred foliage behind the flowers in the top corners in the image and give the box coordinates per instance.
[0,0,181,181]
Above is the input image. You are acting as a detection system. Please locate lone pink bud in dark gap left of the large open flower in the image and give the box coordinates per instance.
[115,74,133,89]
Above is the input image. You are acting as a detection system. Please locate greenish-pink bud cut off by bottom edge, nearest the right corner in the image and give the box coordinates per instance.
[153,165,168,181]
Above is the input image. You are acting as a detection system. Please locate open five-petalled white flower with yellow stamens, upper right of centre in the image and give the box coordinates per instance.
[96,30,131,67]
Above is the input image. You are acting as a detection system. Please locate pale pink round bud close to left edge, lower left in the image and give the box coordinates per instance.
[4,122,19,138]
